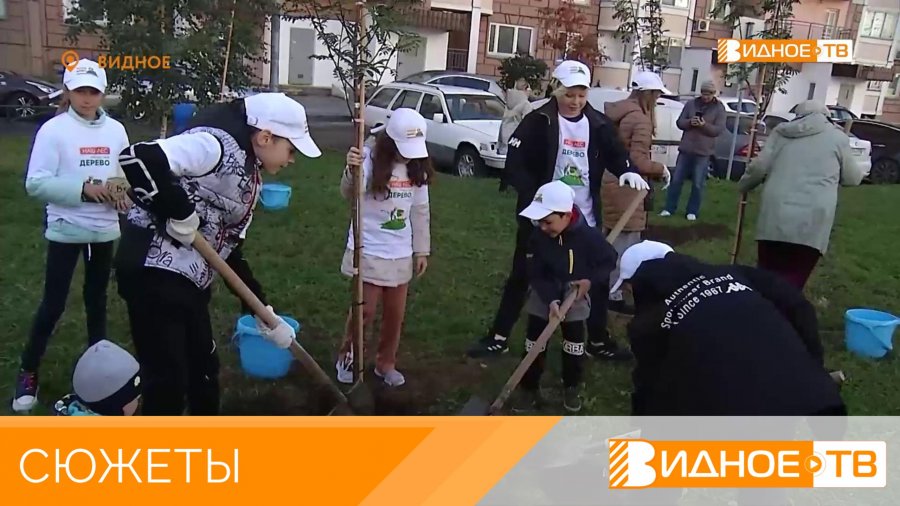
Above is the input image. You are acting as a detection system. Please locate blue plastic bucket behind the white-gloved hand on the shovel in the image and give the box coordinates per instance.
[235,315,300,379]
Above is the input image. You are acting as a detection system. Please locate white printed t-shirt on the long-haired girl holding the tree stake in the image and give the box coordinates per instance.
[347,148,428,260]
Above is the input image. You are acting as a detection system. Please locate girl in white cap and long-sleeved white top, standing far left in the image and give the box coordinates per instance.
[12,60,129,412]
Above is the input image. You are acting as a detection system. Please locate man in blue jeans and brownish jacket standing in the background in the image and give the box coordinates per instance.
[659,81,725,221]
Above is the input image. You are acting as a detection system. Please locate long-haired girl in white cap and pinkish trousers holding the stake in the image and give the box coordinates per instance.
[335,108,434,387]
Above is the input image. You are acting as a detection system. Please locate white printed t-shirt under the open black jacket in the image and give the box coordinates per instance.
[553,115,597,227]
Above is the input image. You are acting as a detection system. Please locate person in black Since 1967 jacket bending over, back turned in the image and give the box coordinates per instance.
[617,241,846,416]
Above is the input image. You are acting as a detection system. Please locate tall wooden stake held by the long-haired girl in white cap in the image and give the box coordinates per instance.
[351,1,366,384]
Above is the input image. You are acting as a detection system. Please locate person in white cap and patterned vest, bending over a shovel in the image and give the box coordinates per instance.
[116,93,321,416]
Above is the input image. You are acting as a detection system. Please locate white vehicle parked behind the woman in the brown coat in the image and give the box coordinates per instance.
[534,88,684,169]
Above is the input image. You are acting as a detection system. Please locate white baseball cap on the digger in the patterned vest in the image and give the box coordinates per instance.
[244,93,322,158]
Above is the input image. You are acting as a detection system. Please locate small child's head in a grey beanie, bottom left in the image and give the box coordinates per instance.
[72,340,141,416]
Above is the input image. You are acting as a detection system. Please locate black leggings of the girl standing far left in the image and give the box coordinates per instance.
[21,241,113,372]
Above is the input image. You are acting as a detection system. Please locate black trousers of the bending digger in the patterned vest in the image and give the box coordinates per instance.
[116,268,219,416]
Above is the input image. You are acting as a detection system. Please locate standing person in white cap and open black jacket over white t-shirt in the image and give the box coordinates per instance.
[468,61,648,360]
